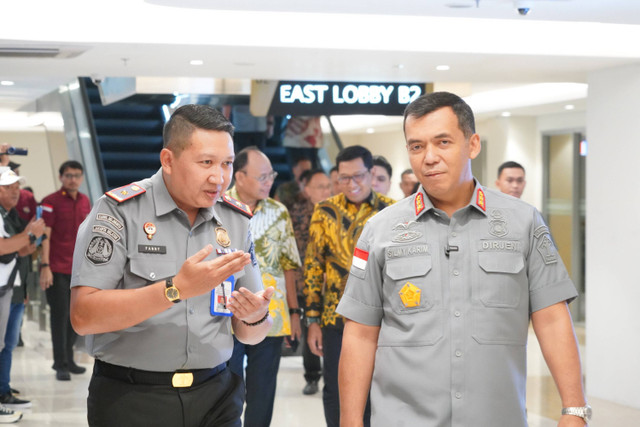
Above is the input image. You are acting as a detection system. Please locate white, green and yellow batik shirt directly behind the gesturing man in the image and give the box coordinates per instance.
[227,187,301,337]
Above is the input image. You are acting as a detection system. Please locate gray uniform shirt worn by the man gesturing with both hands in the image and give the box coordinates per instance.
[71,171,263,371]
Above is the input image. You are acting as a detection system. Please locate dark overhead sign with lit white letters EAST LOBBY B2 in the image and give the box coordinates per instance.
[269,81,427,116]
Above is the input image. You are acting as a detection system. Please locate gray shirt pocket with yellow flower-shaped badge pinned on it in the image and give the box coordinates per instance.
[386,255,436,314]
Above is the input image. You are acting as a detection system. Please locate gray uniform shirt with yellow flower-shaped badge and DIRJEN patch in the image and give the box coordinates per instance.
[337,184,577,427]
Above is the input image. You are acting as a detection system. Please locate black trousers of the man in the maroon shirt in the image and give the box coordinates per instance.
[46,273,78,370]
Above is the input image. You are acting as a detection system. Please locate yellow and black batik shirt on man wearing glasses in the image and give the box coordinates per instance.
[304,191,394,328]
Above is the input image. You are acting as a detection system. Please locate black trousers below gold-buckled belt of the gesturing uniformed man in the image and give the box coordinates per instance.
[87,362,244,427]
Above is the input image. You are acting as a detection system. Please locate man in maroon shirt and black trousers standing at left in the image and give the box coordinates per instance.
[40,160,91,381]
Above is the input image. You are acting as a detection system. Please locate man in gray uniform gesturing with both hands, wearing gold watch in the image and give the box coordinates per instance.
[71,105,273,427]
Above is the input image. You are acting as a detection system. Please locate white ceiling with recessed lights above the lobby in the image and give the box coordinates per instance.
[0,0,640,120]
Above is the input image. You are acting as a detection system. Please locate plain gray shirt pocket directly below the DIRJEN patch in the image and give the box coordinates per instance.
[476,252,524,308]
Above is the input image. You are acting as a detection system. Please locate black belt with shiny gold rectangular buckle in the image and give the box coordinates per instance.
[93,359,227,387]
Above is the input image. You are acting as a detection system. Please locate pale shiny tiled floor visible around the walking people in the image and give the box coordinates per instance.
[6,321,640,427]
